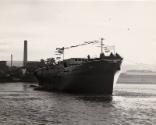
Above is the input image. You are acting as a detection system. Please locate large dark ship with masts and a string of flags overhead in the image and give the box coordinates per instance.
[34,38,123,95]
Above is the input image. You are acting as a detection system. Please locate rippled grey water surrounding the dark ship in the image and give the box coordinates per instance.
[0,83,156,125]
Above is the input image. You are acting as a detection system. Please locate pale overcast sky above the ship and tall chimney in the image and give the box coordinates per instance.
[0,0,156,64]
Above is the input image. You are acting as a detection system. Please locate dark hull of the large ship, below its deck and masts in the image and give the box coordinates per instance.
[35,60,121,95]
